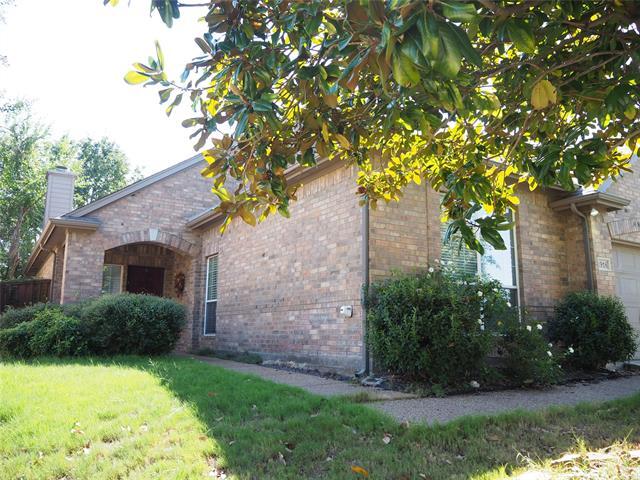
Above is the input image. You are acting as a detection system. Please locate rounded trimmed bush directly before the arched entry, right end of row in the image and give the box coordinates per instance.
[81,293,185,355]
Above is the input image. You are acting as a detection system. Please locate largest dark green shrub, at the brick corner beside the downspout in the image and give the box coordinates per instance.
[366,269,509,385]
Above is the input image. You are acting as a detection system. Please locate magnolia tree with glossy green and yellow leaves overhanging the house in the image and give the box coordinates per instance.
[111,0,640,251]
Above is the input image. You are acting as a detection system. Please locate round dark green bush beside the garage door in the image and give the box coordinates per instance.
[549,292,636,370]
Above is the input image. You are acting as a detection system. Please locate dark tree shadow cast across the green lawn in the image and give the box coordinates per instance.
[15,357,640,479]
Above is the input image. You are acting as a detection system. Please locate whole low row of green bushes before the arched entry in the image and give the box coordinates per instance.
[0,293,185,358]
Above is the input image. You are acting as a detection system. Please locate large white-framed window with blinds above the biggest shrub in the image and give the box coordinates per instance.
[440,208,518,306]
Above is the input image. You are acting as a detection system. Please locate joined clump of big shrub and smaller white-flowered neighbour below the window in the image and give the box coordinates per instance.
[366,268,560,387]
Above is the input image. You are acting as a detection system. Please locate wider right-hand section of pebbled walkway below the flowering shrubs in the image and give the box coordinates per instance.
[370,375,640,423]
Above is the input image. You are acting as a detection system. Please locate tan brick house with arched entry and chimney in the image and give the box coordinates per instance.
[27,156,640,369]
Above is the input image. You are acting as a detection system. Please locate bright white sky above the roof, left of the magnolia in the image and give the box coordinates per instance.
[0,0,202,175]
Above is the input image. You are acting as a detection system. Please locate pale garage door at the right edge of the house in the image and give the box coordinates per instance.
[613,245,640,358]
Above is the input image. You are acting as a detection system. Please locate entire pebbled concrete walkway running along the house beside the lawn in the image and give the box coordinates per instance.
[190,355,640,423]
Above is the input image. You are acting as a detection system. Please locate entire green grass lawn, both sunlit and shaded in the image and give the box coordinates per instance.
[0,357,640,480]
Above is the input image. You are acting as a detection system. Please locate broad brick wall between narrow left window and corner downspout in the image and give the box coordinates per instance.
[195,168,362,369]
